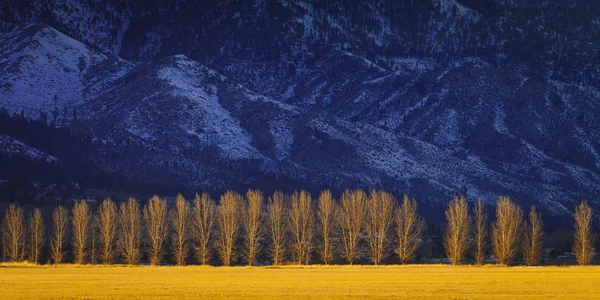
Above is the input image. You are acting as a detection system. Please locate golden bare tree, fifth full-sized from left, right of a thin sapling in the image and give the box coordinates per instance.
[98,198,118,264]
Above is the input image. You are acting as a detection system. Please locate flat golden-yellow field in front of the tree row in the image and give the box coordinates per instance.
[0,265,600,299]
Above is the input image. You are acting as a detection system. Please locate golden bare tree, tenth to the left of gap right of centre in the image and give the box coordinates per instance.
[170,194,191,266]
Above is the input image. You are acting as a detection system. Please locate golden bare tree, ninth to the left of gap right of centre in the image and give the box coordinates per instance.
[193,193,216,265]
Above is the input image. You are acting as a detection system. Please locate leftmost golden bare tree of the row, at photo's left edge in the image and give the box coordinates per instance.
[4,204,26,262]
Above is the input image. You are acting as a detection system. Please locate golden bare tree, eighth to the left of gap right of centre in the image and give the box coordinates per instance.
[217,191,243,266]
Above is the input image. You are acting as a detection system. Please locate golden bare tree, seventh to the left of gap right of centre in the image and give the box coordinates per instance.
[242,190,264,266]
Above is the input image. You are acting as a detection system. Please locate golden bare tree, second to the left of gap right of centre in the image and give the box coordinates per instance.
[366,190,396,265]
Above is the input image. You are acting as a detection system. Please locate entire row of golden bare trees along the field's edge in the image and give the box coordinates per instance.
[0,190,595,266]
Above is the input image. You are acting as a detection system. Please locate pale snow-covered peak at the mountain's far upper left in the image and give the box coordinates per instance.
[0,25,132,118]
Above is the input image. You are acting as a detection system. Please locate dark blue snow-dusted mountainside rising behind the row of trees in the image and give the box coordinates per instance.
[0,0,600,215]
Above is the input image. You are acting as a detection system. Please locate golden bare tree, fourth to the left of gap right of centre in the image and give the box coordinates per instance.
[317,190,338,265]
